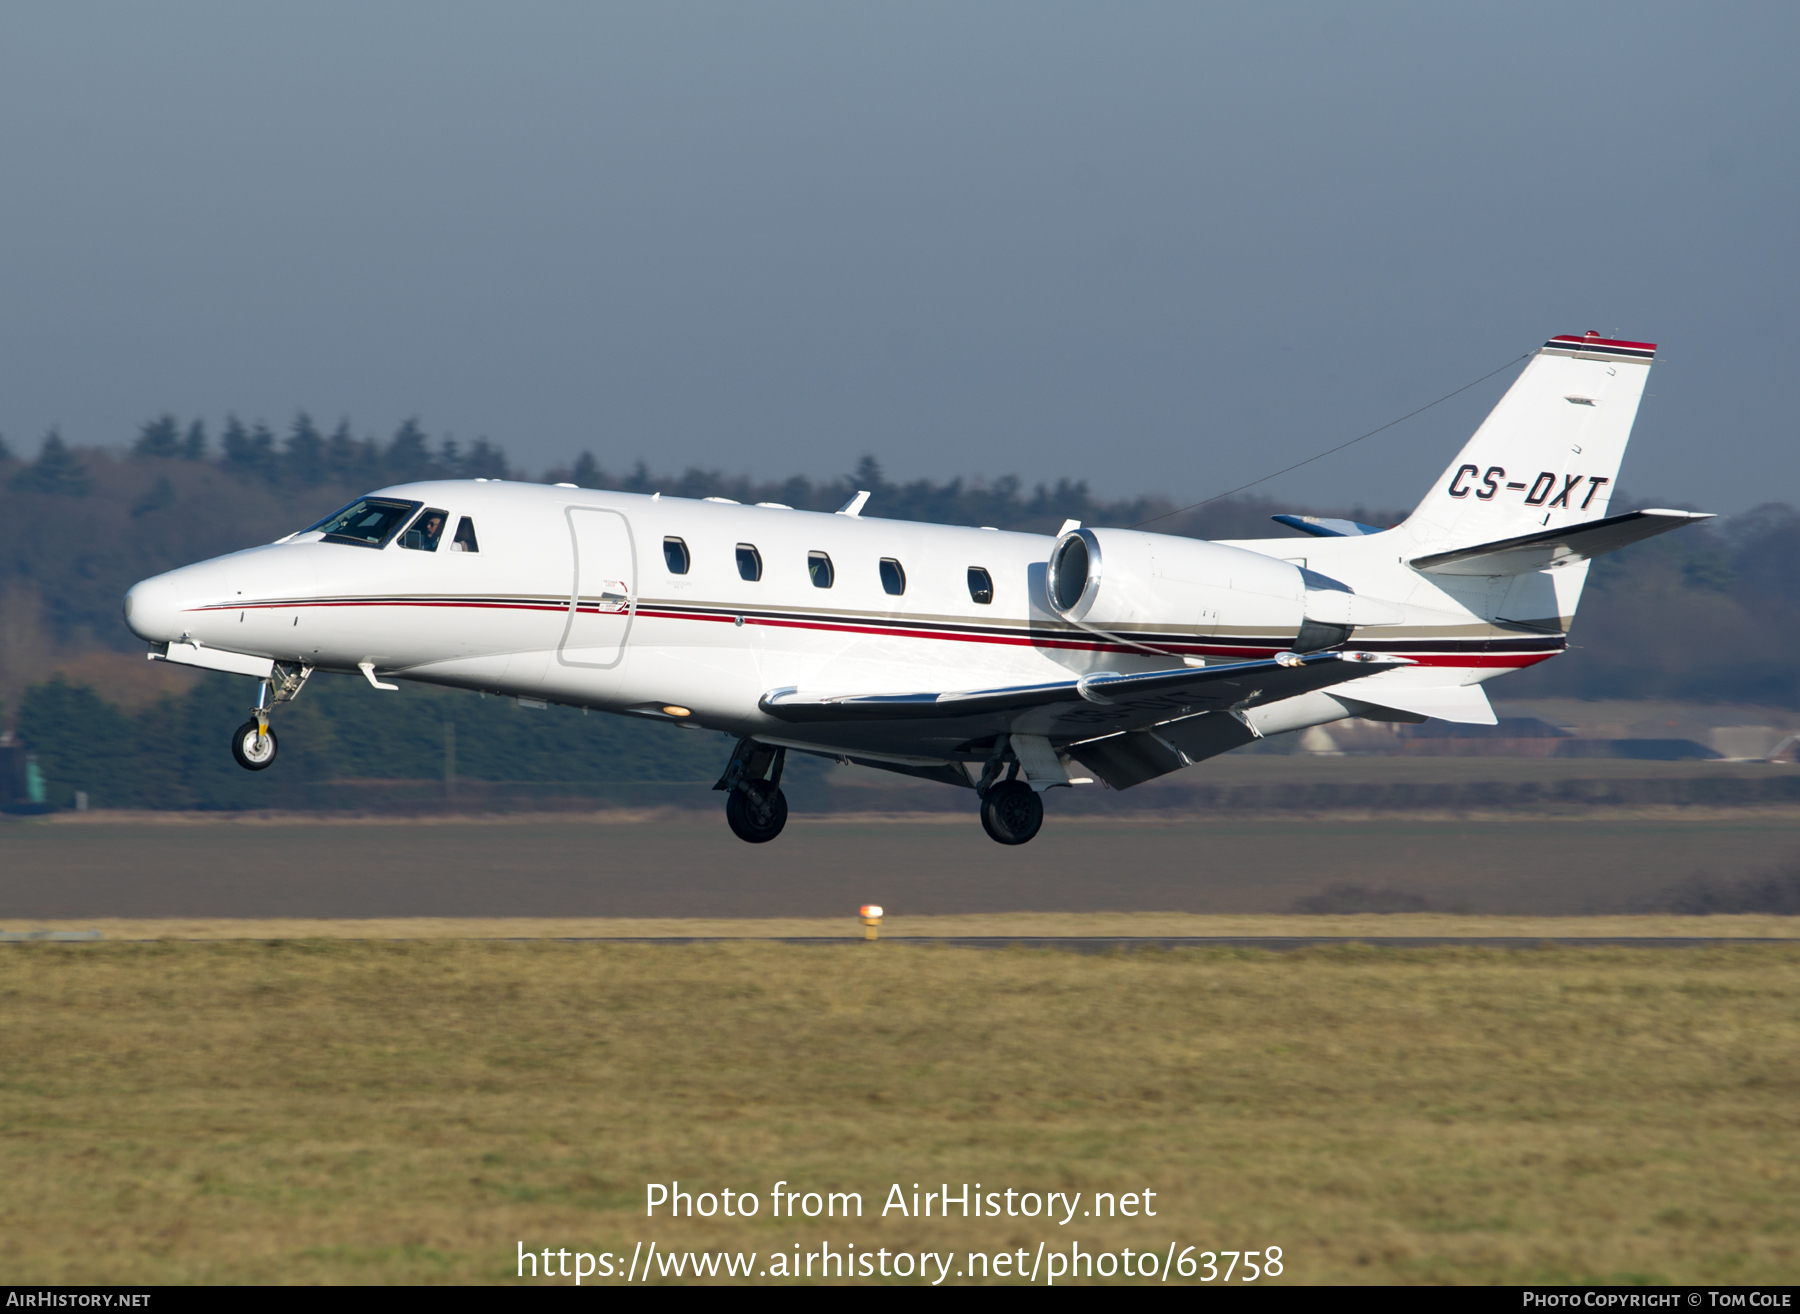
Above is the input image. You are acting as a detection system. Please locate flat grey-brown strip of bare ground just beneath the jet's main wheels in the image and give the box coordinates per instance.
[0,814,1800,918]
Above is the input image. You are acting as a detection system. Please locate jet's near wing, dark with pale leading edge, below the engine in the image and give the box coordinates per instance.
[760,652,1411,743]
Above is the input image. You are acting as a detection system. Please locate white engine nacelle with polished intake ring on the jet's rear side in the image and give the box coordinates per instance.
[1046,529,1307,634]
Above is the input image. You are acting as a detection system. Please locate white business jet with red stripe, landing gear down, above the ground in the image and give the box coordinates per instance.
[124,333,1706,844]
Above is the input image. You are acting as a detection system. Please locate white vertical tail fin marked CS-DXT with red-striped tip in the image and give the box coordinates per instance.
[1402,333,1656,549]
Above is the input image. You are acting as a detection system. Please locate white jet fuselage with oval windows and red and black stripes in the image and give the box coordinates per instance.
[128,481,1579,761]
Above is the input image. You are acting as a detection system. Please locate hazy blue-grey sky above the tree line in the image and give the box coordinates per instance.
[0,0,1800,513]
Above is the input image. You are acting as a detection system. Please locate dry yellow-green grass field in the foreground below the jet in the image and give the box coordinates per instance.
[0,940,1800,1283]
